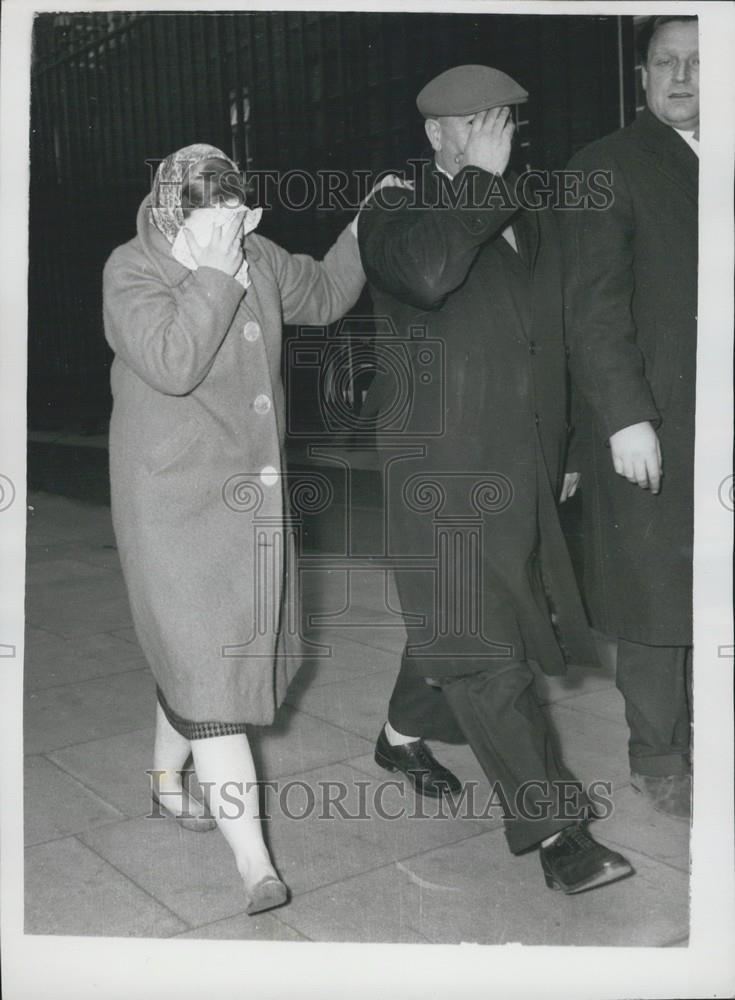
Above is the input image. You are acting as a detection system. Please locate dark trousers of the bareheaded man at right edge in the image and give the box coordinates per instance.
[616,639,692,776]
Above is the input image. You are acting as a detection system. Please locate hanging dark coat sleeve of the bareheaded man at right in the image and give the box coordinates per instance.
[559,146,660,441]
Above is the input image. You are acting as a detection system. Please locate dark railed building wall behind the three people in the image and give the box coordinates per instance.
[29,11,634,429]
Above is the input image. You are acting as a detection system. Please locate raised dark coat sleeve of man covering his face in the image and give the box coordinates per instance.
[358,167,518,309]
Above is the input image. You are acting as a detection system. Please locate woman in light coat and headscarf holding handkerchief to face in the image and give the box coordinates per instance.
[104,144,364,913]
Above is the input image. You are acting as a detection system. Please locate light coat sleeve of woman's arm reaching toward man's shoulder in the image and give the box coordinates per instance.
[259,226,365,325]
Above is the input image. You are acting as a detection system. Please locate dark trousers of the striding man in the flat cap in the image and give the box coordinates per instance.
[388,658,587,854]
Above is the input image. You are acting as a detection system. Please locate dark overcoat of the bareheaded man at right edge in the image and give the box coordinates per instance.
[562,110,699,645]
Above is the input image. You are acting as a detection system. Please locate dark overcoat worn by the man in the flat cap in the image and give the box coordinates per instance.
[359,167,596,677]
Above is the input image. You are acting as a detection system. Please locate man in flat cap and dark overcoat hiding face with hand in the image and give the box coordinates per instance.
[359,66,632,893]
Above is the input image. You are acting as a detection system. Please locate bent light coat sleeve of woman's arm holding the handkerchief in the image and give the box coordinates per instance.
[103,247,244,396]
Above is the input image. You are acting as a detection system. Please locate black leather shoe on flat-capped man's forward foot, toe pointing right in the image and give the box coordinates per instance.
[539,826,634,895]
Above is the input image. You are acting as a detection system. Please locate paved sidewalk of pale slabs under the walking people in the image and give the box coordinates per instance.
[25,492,689,946]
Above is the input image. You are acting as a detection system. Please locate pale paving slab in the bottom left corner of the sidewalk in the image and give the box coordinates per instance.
[25,837,187,937]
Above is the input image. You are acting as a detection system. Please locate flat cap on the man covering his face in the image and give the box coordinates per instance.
[416,66,528,118]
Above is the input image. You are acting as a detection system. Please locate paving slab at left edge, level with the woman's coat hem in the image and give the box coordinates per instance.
[24,670,156,753]
